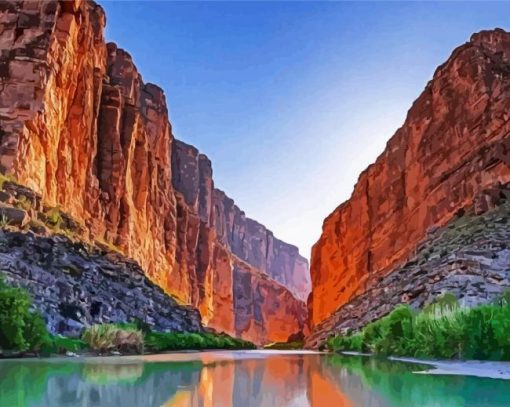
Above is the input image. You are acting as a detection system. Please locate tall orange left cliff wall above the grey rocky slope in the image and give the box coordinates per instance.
[0,0,310,343]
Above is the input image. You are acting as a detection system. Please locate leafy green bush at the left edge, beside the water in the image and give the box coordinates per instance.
[0,279,49,351]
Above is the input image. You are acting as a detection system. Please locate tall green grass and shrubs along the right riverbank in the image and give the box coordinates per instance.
[327,294,510,360]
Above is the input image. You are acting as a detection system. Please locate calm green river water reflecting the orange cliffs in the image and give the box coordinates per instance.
[0,351,510,407]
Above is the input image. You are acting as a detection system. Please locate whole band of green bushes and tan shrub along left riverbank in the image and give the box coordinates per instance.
[0,276,255,355]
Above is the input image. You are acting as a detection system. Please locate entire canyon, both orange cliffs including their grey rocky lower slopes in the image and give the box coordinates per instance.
[0,0,510,348]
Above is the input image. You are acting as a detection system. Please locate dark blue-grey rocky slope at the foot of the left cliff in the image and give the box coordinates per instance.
[0,231,203,336]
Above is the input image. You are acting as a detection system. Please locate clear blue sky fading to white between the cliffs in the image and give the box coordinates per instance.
[100,0,510,258]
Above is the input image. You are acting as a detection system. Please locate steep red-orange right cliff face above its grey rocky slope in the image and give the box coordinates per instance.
[309,30,510,326]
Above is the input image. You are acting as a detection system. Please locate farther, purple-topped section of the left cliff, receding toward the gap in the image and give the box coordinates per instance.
[172,140,310,341]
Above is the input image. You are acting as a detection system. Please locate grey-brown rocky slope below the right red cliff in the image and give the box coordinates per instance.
[306,194,510,348]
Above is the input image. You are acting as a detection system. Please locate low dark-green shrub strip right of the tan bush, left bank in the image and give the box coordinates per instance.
[145,332,255,352]
